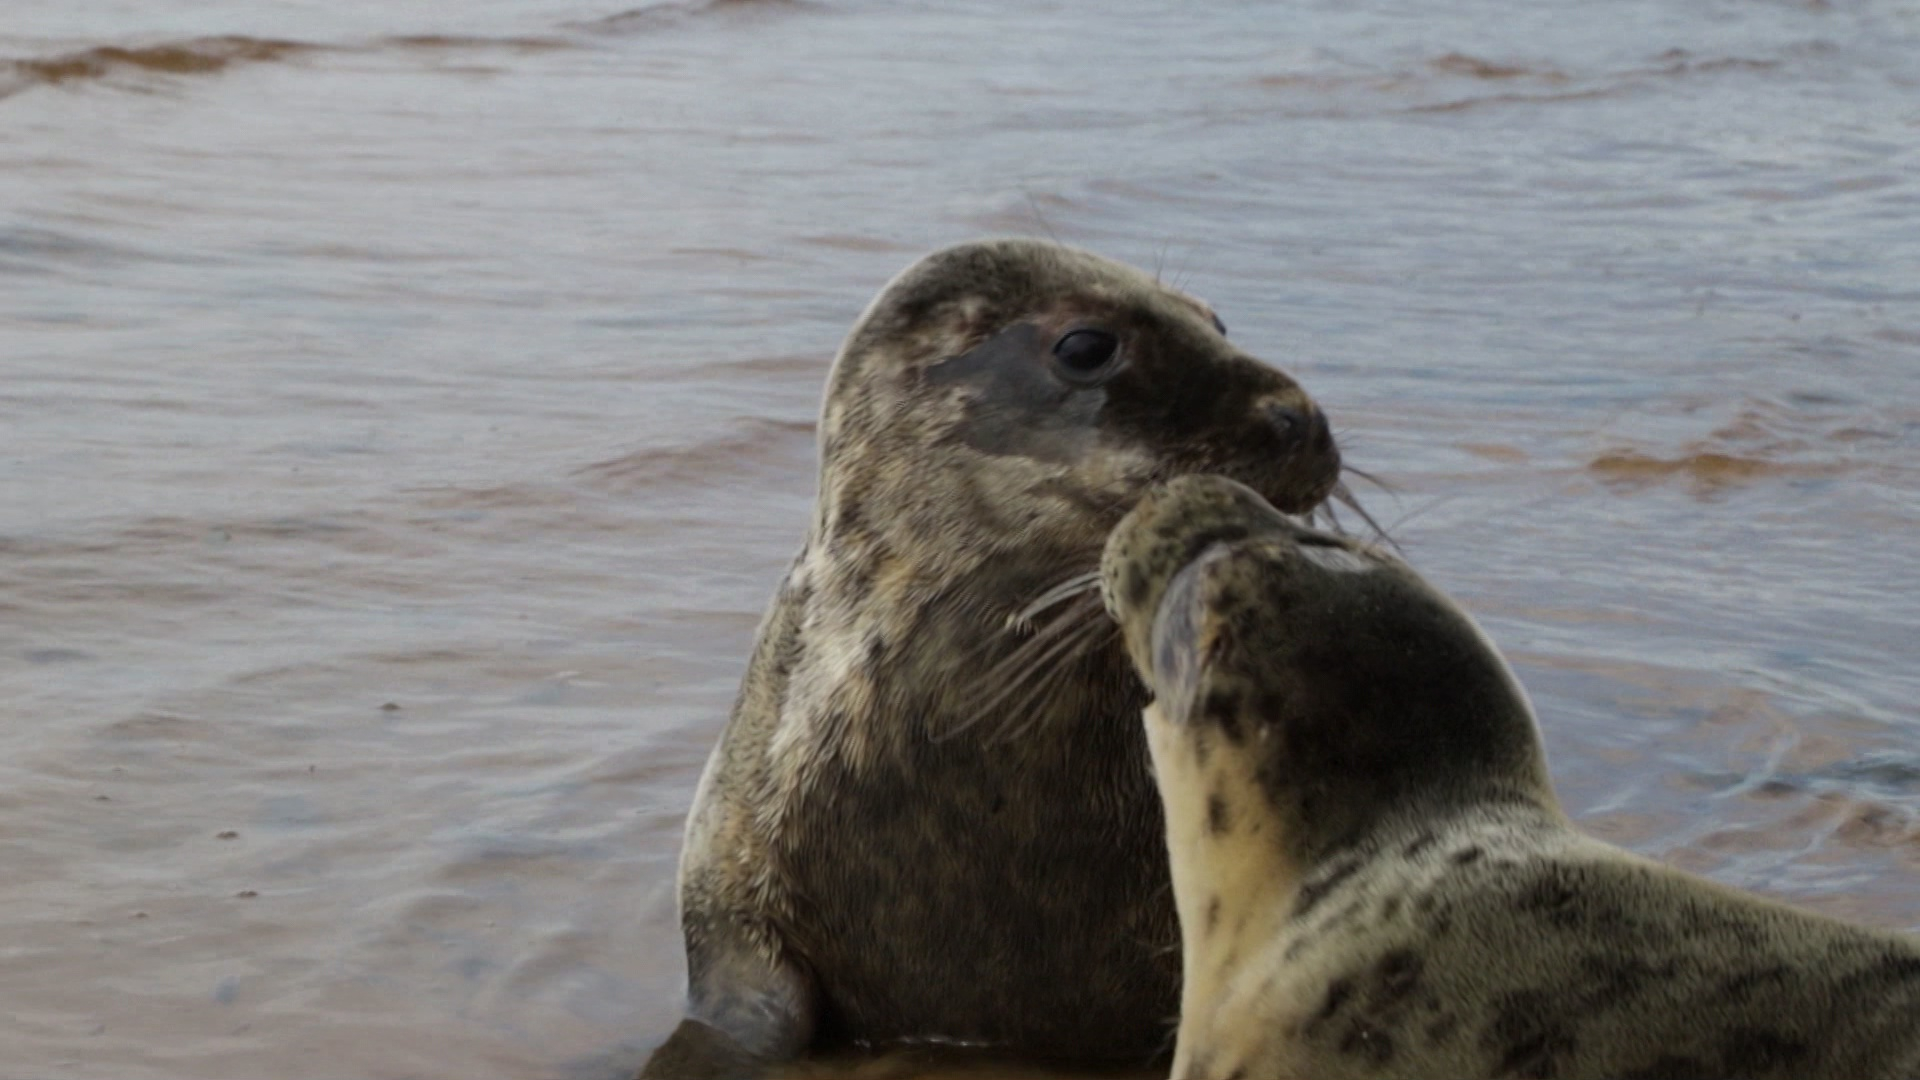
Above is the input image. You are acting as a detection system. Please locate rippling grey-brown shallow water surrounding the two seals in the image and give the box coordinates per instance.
[0,0,1920,1080]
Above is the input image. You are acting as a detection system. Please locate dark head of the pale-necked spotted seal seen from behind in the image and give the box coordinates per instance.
[1102,477,1551,861]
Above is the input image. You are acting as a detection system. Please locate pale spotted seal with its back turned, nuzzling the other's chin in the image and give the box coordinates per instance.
[1102,477,1920,1080]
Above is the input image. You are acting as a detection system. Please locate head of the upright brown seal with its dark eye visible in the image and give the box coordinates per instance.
[816,240,1340,586]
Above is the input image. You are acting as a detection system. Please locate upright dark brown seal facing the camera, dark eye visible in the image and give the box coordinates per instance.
[643,240,1340,1078]
